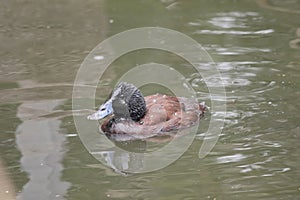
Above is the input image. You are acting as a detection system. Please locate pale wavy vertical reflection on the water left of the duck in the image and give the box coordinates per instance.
[16,100,70,199]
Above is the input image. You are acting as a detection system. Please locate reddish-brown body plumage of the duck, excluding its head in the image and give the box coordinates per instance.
[101,94,206,138]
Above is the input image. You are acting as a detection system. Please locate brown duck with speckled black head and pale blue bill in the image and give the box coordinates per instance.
[87,82,207,140]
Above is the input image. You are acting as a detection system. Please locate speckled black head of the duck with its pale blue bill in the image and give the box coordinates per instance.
[88,82,146,121]
